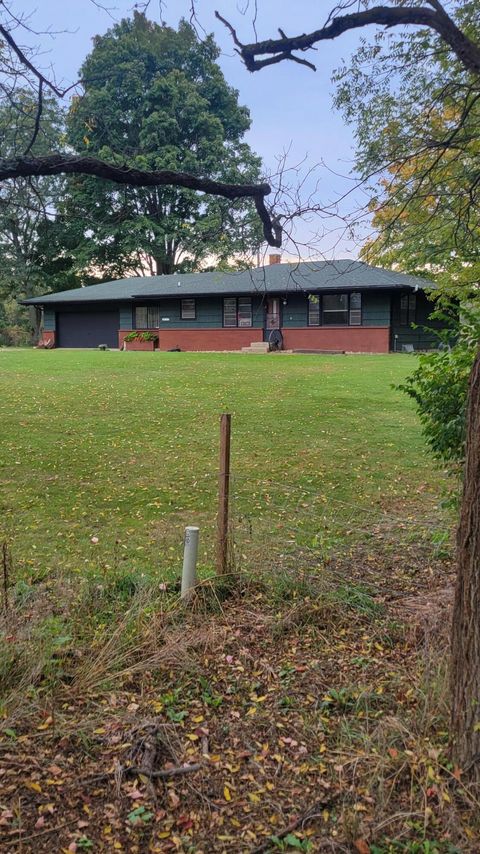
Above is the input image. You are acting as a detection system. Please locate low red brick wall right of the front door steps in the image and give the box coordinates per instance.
[282,326,390,353]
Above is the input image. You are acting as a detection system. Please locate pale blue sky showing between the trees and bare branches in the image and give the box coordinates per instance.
[10,0,376,260]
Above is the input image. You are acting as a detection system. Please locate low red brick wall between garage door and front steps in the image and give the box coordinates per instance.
[118,329,263,351]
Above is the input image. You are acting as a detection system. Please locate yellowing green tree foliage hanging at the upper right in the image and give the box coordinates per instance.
[336,3,480,298]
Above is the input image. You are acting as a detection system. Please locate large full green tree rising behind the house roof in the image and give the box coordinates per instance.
[63,12,263,278]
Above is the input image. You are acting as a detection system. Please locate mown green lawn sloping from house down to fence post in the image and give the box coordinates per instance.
[0,350,442,580]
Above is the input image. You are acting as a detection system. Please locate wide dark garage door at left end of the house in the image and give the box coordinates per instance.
[57,311,119,347]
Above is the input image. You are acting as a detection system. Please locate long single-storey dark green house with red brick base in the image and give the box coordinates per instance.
[23,255,436,353]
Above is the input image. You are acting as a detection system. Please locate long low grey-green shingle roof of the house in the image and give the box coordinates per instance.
[24,259,433,305]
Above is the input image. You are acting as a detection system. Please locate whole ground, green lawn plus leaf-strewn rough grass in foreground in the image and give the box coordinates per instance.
[0,350,468,854]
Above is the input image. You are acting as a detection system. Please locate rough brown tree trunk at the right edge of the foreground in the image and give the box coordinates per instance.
[451,350,480,783]
